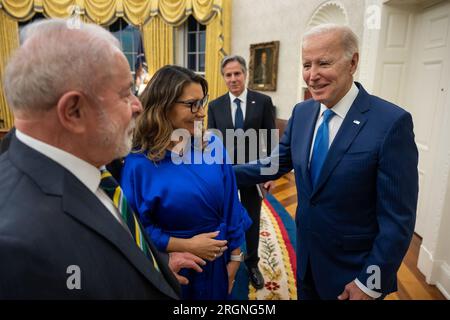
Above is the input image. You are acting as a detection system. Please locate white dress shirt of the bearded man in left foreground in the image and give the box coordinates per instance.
[16,129,128,231]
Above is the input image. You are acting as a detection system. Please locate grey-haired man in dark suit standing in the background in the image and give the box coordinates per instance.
[208,55,275,289]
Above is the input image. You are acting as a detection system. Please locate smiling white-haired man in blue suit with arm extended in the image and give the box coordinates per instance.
[234,25,418,300]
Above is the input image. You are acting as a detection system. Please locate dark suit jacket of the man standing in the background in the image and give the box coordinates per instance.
[208,90,275,162]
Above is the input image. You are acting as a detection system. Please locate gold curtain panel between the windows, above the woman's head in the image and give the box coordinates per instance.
[142,16,173,76]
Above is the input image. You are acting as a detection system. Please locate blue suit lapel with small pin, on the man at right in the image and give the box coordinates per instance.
[312,86,369,196]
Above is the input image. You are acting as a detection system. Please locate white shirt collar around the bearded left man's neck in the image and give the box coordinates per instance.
[16,129,100,193]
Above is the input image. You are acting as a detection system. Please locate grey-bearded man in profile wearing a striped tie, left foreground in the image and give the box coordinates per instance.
[0,19,202,299]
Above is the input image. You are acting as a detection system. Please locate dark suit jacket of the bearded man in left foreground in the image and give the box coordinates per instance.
[0,136,179,299]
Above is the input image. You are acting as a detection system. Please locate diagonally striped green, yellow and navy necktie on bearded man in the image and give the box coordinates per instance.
[100,169,159,271]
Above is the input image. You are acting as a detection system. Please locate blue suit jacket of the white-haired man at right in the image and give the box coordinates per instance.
[235,83,418,299]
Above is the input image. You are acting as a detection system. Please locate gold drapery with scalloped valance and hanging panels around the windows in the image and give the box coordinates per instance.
[0,0,231,128]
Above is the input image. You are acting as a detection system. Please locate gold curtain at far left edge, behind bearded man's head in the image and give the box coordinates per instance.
[0,10,19,129]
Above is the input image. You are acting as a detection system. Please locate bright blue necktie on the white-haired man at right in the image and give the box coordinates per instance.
[310,109,335,186]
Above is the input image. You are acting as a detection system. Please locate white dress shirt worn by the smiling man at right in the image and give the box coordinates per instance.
[309,83,381,299]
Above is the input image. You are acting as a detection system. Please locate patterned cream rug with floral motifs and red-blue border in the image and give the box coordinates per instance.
[232,194,297,300]
